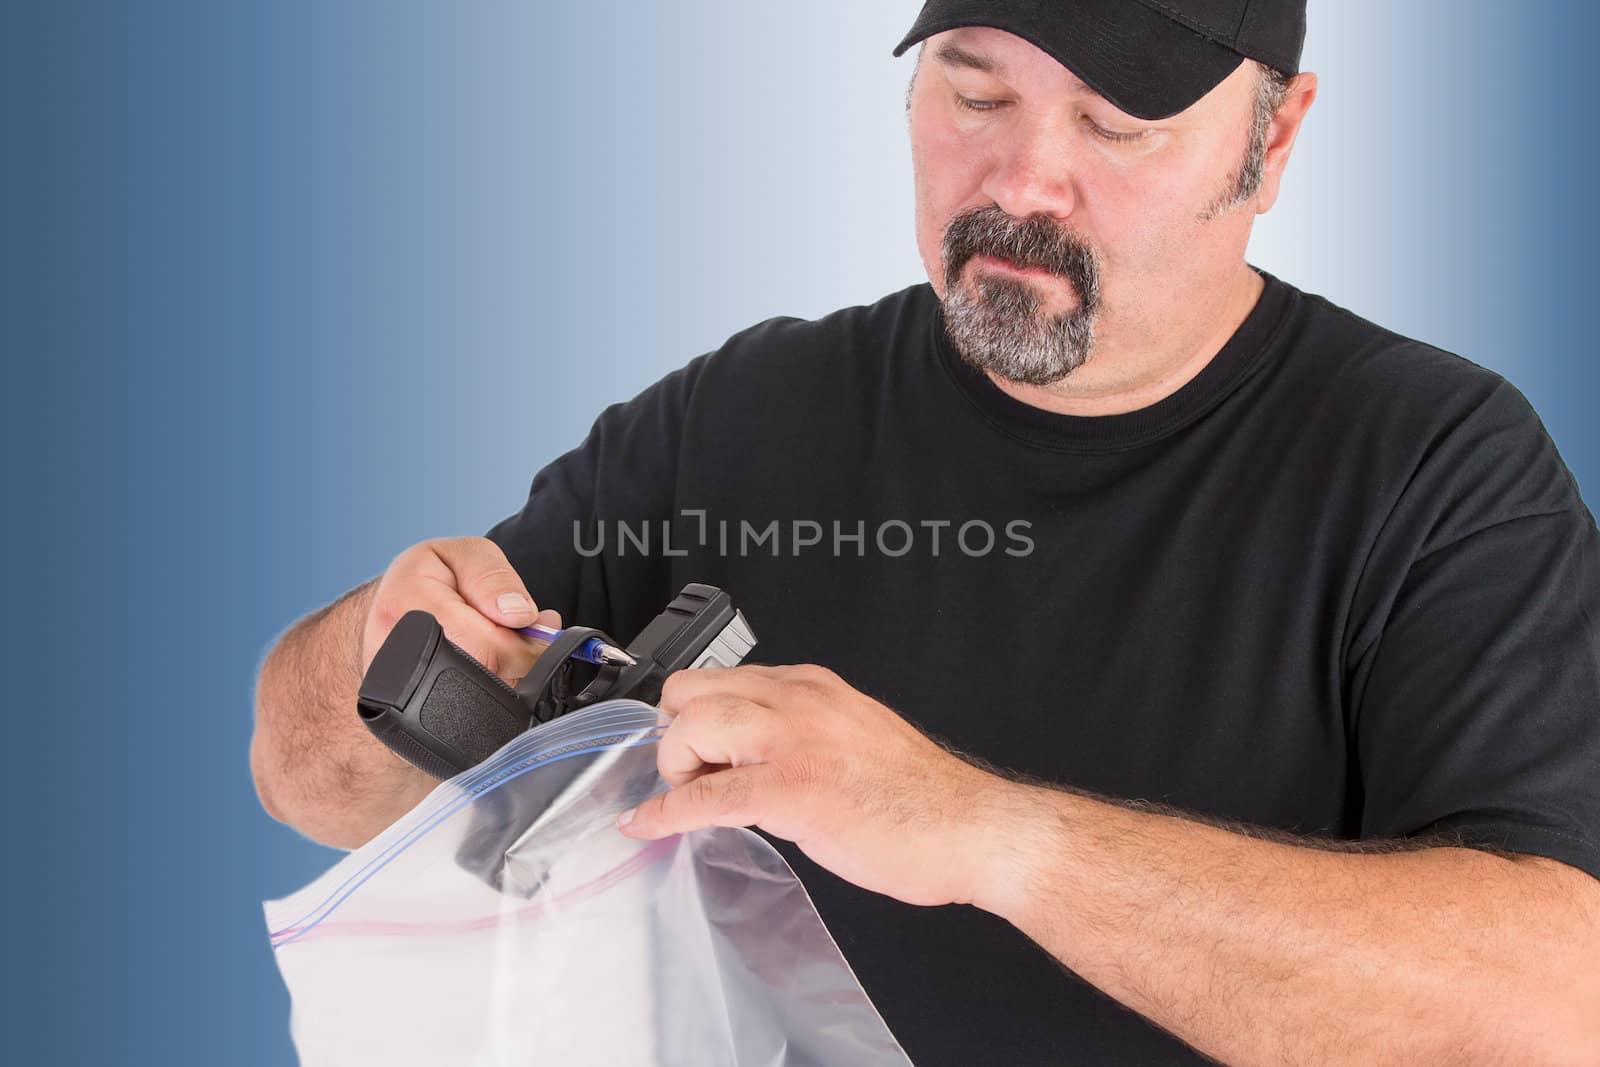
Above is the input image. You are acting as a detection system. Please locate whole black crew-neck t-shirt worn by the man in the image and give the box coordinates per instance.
[490,268,1600,1067]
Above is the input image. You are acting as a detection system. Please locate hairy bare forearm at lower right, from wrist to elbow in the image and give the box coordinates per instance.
[974,782,1600,1064]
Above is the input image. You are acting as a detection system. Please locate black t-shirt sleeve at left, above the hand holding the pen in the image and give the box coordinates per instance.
[486,357,706,640]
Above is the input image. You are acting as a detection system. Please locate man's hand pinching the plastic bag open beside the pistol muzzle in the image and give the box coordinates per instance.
[618,665,1010,905]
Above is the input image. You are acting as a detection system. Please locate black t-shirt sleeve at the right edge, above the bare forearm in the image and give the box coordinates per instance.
[1347,382,1600,878]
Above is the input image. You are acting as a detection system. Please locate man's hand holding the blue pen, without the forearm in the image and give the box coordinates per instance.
[361,537,562,687]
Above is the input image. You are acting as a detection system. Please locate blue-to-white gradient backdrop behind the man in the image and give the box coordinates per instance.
[15,0,1600,1067]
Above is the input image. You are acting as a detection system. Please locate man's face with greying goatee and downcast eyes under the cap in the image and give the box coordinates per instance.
[909,27,1256,384]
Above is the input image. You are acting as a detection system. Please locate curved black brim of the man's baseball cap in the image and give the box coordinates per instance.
[894,0,1245,120]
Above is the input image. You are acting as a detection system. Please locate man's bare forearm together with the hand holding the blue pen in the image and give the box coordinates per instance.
[250,537,562,848]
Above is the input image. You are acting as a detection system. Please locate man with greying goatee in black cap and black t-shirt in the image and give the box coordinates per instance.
[253,0,1600,1064]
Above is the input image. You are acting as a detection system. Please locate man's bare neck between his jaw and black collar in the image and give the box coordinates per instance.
[989,264,1266,416]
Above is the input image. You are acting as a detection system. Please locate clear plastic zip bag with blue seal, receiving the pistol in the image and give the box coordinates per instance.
[264,701,909,1067]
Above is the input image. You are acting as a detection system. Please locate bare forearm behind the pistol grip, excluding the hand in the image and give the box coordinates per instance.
[250,581,437,848]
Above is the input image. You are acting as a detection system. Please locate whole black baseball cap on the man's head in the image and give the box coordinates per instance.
[894,0,1306,118]
